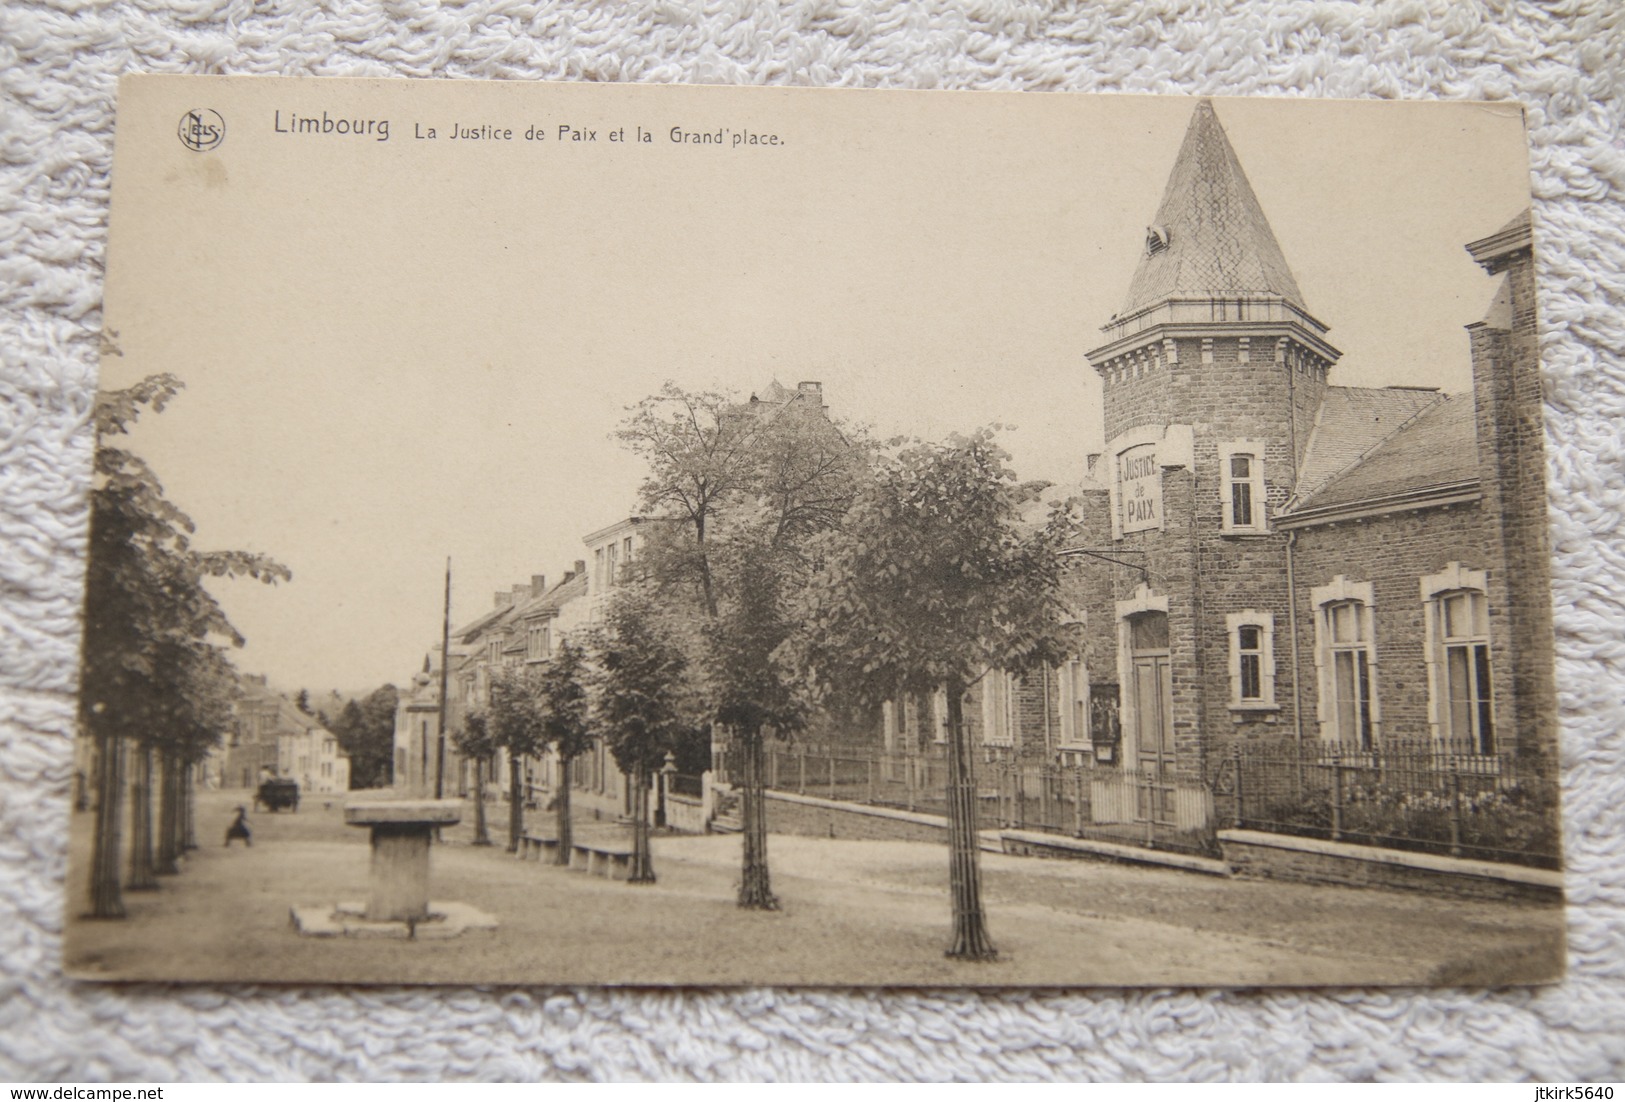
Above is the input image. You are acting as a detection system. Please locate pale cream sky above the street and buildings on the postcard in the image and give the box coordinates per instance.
[102,78,1529,692]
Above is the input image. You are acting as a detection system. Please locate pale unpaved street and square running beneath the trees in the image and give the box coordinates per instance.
[65,792,1563,987]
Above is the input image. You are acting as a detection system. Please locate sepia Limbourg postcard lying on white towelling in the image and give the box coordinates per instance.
[65,76,1563,987]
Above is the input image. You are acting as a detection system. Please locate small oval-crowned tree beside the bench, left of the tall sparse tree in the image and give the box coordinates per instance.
[593,587,700,884]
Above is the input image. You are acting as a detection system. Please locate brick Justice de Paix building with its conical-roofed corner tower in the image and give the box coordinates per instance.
[1033,101,1555,827]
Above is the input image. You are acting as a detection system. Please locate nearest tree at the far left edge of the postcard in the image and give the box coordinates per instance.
[80,375,293,918]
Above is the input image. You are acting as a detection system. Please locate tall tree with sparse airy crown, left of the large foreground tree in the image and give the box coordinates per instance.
[618,382,871,910]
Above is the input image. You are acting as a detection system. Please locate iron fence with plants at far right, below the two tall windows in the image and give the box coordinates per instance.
[1212,740,1562,868]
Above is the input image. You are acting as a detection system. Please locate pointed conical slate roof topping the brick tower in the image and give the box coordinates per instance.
[1121,99,1308,314]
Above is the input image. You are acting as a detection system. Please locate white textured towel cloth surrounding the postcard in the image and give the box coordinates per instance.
[0,0,1625,1082]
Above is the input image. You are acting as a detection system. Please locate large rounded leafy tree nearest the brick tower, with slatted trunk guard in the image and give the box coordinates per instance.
[793,429,1071,961]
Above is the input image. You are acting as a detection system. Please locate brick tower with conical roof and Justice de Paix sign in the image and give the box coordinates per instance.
[1087,99,1339,789]
